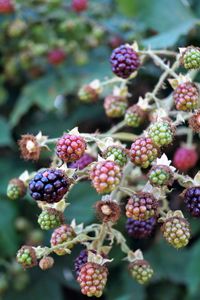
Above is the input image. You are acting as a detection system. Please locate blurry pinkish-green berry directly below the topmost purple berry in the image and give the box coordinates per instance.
[104,95,128,118]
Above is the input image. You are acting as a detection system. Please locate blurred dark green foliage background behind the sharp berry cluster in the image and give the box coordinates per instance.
[0,0,200,300]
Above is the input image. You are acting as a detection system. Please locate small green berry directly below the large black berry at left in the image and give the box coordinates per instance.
[38,208,64,230]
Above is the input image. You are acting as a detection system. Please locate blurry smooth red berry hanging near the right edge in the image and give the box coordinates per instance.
[173,147,198,172]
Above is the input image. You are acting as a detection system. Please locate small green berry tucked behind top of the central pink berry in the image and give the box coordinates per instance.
[102,145,128,167]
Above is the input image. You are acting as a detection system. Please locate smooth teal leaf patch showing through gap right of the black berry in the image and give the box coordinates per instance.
[66,182,99,223]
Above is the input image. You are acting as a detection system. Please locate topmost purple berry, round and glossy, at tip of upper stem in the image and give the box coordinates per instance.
[110,45,140,78]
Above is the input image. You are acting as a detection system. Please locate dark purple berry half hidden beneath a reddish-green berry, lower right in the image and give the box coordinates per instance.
[126,218,156,239]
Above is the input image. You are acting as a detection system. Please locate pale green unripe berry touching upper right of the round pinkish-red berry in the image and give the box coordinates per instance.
[148,120,174,147]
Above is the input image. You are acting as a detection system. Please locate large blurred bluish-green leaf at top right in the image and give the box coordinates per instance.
[118,0,197,48]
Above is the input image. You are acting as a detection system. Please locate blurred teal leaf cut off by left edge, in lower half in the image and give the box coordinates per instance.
[0,199,17,256]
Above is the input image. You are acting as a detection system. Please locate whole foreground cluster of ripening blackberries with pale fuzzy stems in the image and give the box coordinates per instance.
[11,41,200,297]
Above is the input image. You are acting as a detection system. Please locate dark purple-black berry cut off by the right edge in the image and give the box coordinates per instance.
[184,186,200,217]
